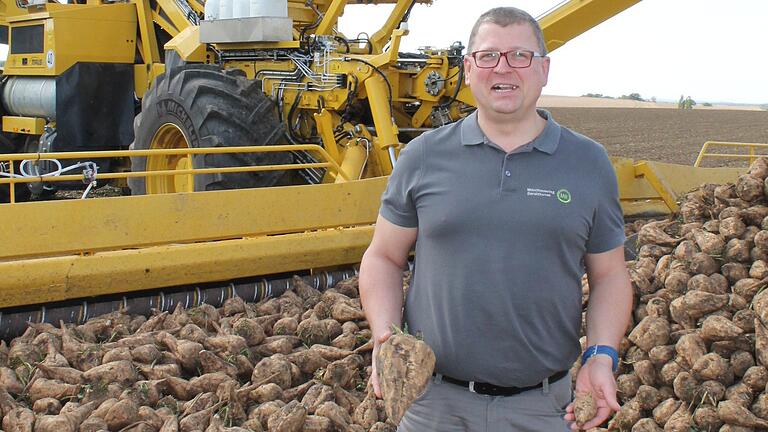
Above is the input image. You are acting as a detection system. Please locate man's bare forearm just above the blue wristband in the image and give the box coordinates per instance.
[587,272,633,348]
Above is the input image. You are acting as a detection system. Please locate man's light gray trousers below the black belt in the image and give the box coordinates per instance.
[397,374,572,432]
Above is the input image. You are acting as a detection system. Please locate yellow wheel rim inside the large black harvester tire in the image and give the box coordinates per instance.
[146,123,195,194]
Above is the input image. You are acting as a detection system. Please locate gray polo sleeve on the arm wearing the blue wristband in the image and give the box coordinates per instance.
[587,151,625,254]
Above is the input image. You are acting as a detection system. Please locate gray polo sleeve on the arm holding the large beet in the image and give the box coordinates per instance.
[379,137,423,228]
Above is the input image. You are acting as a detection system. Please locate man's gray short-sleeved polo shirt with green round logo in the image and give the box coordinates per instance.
[380,110,624,386]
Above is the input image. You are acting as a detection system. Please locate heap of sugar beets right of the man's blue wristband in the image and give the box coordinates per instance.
[574,158,768,432]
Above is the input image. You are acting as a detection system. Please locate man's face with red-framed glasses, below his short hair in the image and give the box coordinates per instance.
[464,23,549,117]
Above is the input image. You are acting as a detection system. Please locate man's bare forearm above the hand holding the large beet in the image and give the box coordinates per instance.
[360,254,403,338]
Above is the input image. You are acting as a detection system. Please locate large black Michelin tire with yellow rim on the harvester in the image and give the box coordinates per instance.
[128,65,292,195]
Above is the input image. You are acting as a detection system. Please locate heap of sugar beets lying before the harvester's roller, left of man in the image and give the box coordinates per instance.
[0,278,402,432]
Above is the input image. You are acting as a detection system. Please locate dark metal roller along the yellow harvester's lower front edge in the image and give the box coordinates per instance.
[0,269,357,341]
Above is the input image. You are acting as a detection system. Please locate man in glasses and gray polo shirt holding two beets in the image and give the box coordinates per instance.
[360,8,632,432]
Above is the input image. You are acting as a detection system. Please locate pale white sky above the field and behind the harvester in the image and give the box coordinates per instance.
[339,0,768,104]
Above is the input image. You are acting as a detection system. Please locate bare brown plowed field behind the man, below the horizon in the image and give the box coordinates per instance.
[547,108,768,166]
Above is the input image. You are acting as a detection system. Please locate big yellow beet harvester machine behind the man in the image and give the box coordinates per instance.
[0,0,752,337]
